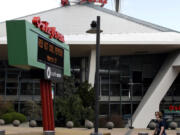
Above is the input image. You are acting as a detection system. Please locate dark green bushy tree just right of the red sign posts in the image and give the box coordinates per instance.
[55,77,94,126]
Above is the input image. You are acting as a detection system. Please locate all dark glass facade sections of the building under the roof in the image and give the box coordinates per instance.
[0,54,180,124]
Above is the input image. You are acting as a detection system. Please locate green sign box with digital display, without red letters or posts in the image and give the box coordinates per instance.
[6,20,71,76]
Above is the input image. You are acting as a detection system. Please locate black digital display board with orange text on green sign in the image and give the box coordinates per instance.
[38,37,64,68]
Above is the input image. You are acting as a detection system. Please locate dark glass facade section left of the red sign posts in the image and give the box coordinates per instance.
[0,61,40,112]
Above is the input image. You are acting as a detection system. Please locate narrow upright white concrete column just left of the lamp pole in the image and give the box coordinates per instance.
[88,49,96,86]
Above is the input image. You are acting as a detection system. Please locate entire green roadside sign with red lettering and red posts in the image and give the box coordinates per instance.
[6,17,71,135]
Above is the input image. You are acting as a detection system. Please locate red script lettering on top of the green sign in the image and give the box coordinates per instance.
[32,17,65,43]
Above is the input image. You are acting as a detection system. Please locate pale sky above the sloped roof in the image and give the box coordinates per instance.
[0,0,180,31]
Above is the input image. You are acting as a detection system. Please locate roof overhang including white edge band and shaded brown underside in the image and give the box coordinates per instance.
[0,32,180,57]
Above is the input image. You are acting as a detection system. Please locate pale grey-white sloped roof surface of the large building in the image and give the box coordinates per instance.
[0,4,177,37]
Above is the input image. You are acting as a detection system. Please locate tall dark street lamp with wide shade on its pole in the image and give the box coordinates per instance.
[86,16,103,135]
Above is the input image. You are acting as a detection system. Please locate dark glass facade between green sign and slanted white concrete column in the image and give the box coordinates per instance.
[71,54,174,123]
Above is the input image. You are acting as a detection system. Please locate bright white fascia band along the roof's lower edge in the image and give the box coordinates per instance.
[65,32,180,45]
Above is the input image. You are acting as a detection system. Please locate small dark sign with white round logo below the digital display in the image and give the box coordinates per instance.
[44,65,62,82]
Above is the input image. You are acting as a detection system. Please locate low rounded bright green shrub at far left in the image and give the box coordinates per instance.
[1,112,27,124]
